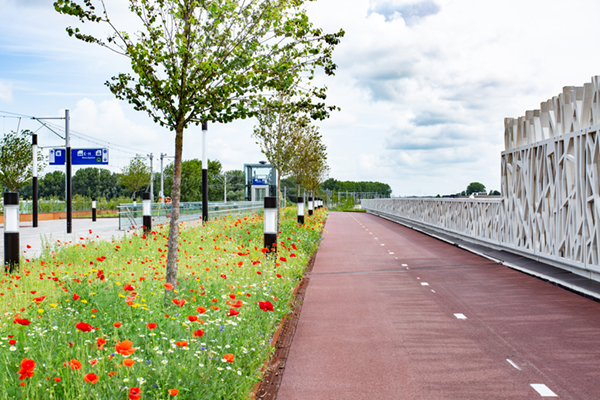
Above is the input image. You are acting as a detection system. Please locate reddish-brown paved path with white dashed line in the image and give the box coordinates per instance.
[277,213,600,400]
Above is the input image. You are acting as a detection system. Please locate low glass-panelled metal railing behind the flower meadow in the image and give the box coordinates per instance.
[119,201,264,230]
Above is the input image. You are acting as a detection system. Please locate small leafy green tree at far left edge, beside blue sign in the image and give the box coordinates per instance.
[0,130,45,192]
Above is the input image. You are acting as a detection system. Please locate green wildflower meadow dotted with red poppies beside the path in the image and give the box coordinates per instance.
[0,208,326,400]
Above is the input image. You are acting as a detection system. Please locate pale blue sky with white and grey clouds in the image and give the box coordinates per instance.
[0,0,600,196]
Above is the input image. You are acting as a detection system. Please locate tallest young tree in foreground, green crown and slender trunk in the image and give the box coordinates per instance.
[54,0,344,296]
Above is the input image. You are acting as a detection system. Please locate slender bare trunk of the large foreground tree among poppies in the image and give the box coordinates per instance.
[165,124,183,305]
